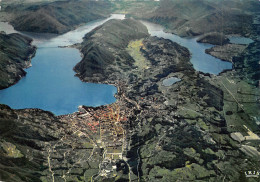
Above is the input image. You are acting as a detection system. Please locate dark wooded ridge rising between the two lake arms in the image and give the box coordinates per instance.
[74,19,148,82]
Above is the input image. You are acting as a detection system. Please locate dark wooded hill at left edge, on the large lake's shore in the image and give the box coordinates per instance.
[0,33,36,89]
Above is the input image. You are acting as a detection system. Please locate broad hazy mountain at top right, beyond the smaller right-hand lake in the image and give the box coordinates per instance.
[135,0,259,36]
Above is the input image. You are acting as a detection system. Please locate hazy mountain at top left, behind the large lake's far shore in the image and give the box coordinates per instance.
[4,0,110,34]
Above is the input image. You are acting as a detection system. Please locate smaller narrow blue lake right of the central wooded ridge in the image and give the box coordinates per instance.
[142,21,232,75]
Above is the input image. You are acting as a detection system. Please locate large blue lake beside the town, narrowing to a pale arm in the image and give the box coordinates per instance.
[0,15,124,115]
